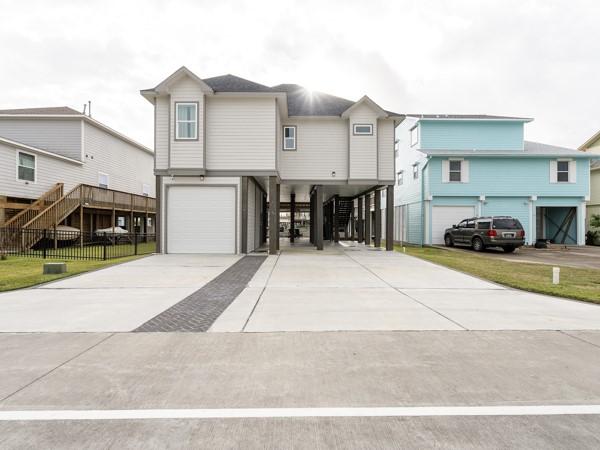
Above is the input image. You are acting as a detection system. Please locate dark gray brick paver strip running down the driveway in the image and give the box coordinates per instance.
[133,256,267,332]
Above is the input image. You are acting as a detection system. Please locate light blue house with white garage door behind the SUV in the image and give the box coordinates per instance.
[394,115,592,245]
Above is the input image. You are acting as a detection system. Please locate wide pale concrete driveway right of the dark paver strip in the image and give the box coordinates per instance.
[210,243,600,332]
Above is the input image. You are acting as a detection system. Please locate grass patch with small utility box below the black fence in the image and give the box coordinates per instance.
[0,256,149,292]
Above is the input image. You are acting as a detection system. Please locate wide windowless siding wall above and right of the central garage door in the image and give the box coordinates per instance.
[206,96,277,170]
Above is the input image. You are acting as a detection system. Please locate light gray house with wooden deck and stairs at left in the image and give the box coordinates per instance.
[0,107,156,231]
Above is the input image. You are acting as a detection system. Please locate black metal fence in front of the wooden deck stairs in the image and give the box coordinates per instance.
[0,227,156,260]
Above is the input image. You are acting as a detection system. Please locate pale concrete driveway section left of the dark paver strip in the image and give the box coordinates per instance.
[0,255,240,332]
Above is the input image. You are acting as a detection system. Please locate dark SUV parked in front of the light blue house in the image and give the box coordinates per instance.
[444,216,525,253]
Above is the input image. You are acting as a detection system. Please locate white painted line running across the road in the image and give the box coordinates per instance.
[0,405,600,421]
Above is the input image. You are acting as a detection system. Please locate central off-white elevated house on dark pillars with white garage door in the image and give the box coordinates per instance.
[141,67,403,253]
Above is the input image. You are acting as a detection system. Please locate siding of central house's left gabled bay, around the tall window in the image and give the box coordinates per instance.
[169,77,204,169]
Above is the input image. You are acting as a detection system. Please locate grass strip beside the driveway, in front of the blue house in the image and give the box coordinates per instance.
[395,246,600,303]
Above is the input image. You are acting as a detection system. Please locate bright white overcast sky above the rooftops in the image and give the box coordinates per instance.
[0,0,600,147]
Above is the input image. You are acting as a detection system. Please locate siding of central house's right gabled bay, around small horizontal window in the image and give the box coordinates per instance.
[349,104,378,180]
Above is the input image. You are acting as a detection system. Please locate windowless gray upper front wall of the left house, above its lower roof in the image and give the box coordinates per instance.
[0,117,82,160]
